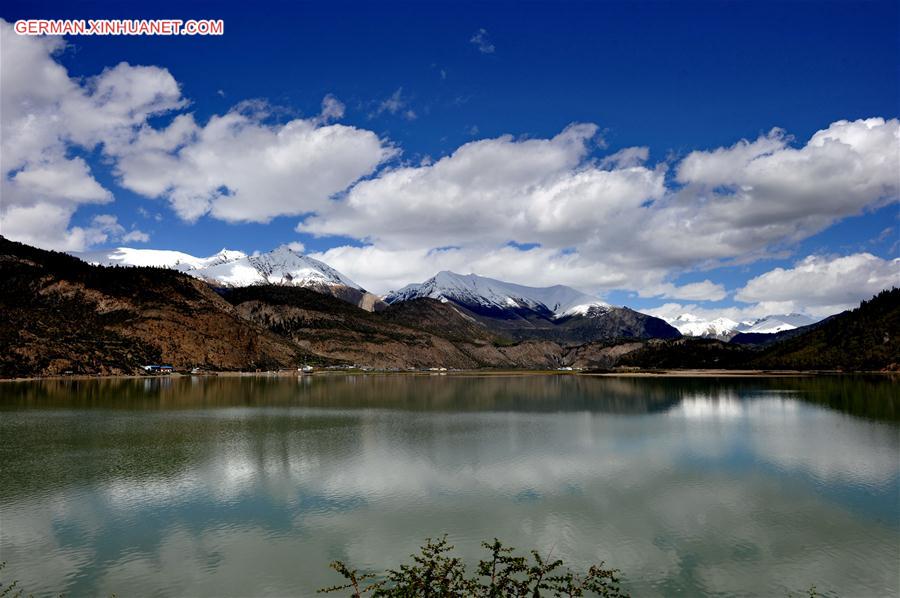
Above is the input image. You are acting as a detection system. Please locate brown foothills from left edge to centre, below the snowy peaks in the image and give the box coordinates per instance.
[0,237,604,377]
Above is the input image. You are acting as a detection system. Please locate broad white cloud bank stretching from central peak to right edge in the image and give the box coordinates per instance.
[297,118,900,301]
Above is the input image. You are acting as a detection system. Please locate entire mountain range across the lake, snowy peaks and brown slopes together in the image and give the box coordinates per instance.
[0,237,900,377]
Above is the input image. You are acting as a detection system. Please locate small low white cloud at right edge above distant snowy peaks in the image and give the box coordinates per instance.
[735,253,900,316]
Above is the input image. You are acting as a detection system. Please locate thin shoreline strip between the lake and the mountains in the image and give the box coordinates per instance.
[0,369,900,384]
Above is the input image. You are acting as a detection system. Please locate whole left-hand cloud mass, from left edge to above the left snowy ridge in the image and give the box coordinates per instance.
[0,21,397,244]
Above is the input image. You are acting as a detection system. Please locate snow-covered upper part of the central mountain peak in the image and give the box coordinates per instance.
[384,271,609,317]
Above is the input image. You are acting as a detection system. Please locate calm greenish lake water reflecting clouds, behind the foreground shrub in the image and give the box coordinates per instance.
[0,375,900,597]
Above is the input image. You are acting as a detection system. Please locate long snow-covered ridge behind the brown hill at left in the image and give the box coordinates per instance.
[74,246,383,311]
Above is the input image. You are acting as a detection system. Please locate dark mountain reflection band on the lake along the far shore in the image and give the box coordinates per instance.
[0,374,900,422]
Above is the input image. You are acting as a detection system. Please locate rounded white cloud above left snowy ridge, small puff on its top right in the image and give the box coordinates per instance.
[116,104,397,222]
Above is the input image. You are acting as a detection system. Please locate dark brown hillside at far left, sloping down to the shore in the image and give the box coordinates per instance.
[0,237,312,377]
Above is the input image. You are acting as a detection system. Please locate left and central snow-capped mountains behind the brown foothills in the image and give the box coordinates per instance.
[79,246,679,343]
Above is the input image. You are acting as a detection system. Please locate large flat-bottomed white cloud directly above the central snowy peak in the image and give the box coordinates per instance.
[298,124,664,248]
